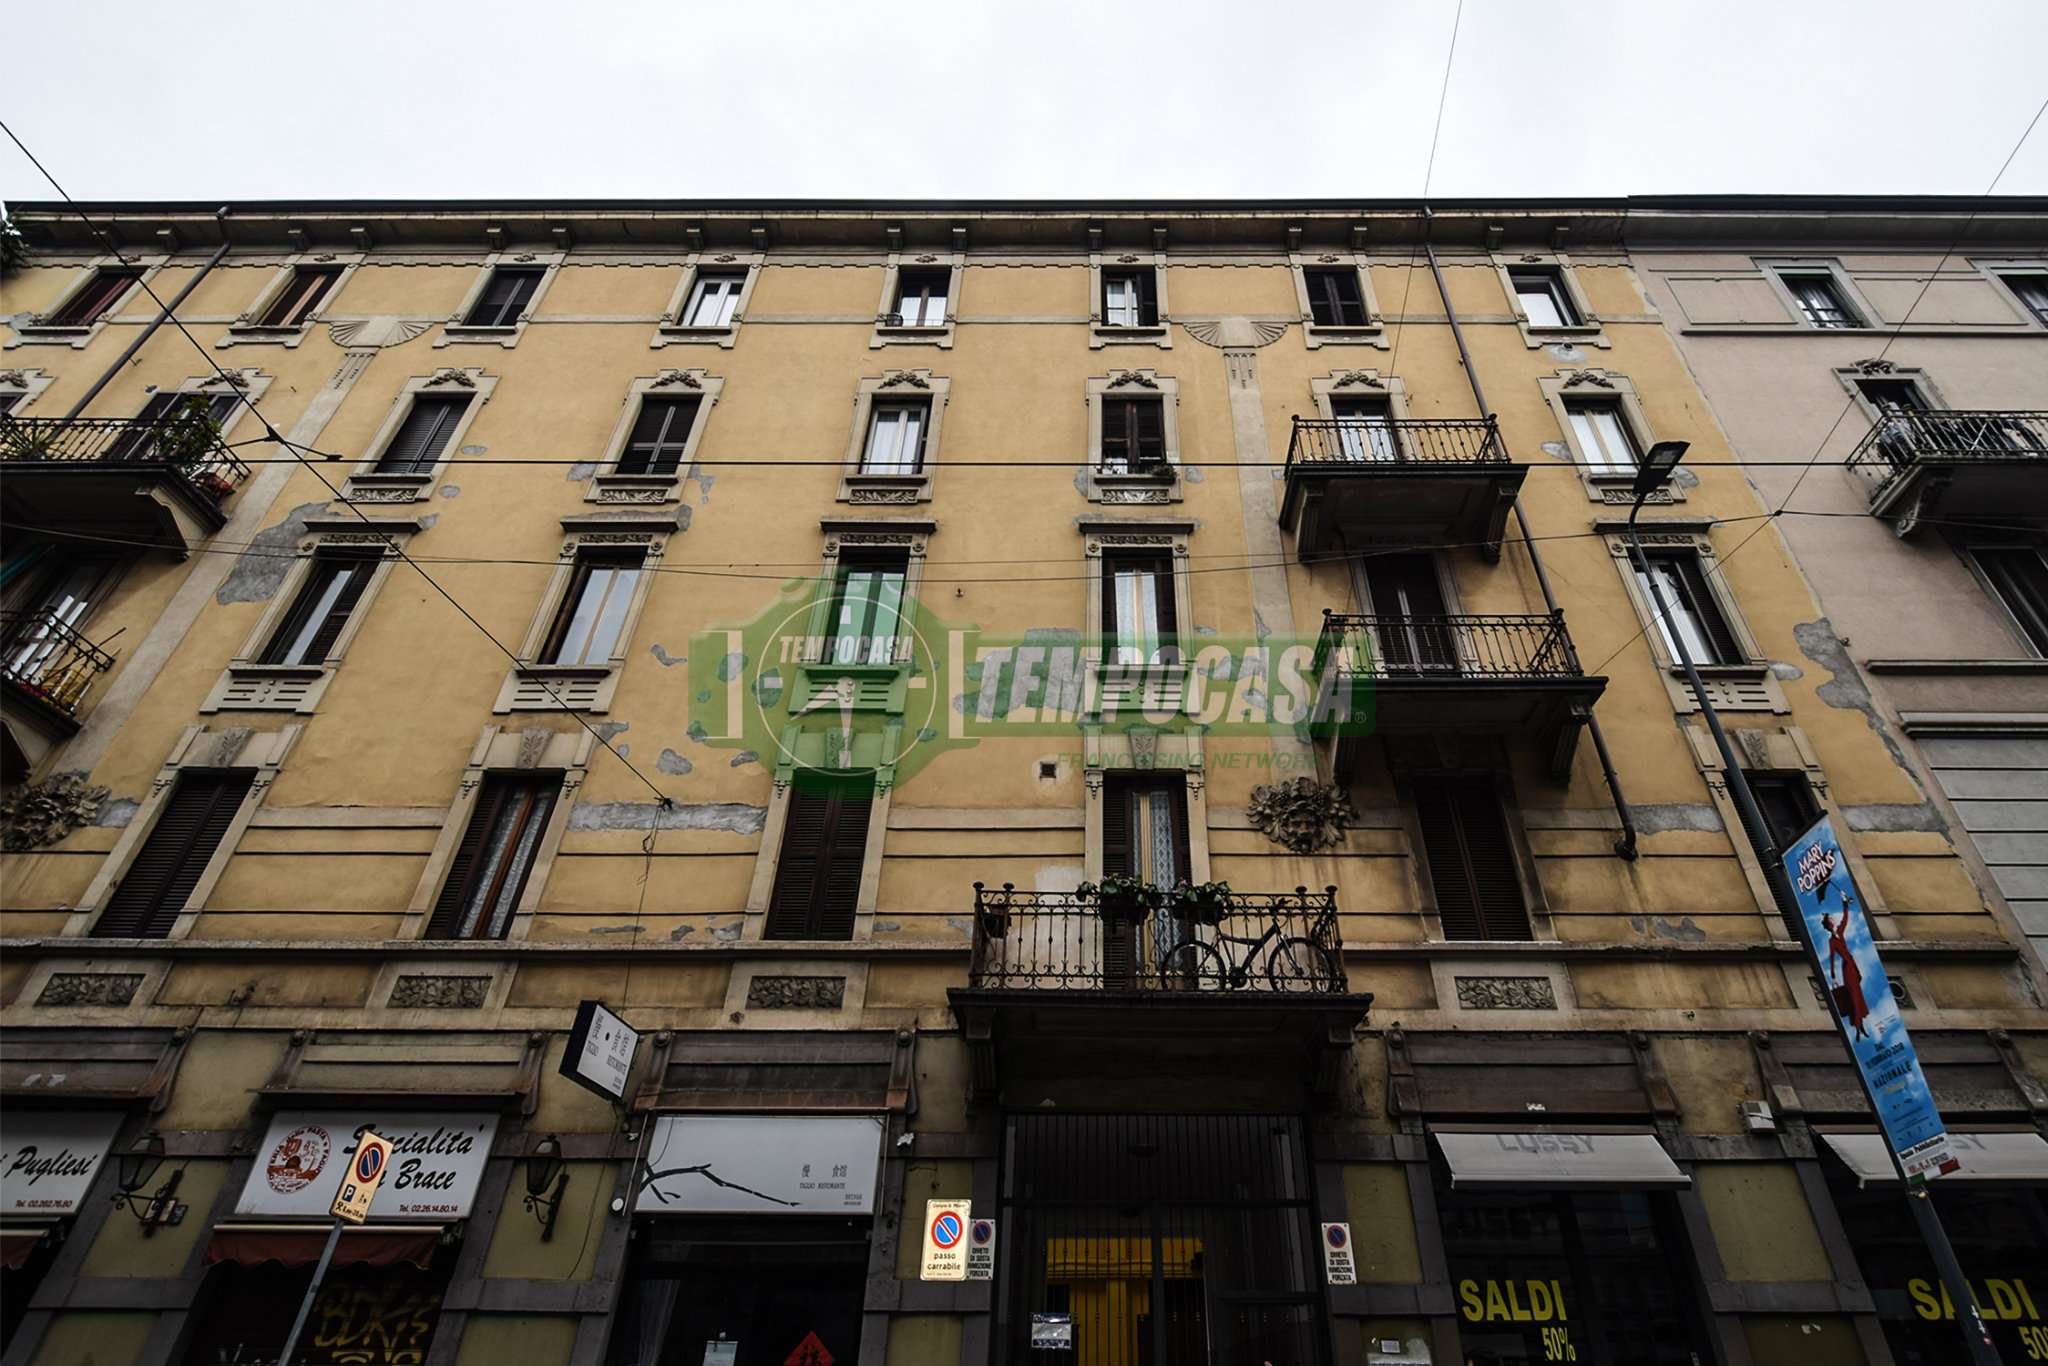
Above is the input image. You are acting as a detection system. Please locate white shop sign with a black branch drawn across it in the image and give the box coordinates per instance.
[633,1114,883,1214]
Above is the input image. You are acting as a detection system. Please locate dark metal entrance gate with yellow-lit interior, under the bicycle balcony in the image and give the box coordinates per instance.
[995,1114,1329,1366]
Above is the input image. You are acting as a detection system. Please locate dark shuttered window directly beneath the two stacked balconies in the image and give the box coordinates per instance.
[1415,776,1534,940]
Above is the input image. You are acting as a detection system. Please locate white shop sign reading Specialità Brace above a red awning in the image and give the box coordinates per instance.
[236,1110,498,1221]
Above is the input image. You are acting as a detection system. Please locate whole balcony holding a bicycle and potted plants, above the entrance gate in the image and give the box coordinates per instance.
[952,883,1372,1106]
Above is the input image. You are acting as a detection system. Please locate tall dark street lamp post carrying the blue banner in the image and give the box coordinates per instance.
[1628,440,1999,1366]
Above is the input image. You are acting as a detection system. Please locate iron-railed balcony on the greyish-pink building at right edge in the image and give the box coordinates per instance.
[1849,410,2048,537]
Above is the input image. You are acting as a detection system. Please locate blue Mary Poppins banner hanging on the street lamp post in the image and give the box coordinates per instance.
[1784,817,1958,1184]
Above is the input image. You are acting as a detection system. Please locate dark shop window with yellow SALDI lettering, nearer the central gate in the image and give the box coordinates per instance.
[1436,1169,1714,1366]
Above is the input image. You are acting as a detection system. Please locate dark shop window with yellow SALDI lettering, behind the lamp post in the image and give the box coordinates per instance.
[1829,1169,2048,1366]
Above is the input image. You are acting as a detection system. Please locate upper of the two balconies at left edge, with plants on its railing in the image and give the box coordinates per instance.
[0,412,250,555]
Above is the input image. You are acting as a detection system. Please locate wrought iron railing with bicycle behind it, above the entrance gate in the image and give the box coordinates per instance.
[969,883,1346,995]
